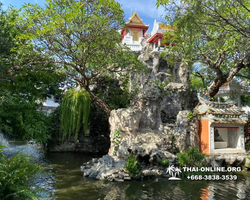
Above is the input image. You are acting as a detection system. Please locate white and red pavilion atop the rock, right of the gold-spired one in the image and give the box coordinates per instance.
[148,19,174,50]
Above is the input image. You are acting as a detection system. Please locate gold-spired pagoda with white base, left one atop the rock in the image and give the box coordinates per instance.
[121,11,149,51]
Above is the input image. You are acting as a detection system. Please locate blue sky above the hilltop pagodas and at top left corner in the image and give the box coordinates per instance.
[0,0,166,31]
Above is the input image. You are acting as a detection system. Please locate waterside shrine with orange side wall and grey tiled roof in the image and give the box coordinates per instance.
[194,93,247,154]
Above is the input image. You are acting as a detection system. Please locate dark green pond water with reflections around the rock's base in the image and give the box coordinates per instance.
[1,135,250,200]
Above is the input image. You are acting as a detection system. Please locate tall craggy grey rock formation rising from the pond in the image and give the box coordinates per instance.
[81,33,202,181]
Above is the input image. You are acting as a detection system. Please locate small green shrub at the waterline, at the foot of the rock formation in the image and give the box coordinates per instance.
[125,154,141,178]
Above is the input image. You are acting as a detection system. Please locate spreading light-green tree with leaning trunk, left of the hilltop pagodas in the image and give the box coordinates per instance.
[20,0,143,115]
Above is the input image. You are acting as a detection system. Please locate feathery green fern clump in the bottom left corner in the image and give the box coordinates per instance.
[0,147,41,200]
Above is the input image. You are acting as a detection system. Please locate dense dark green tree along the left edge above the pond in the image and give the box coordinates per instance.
[0,2,65,142]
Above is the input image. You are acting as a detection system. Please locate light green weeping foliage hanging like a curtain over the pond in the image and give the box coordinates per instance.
[60,89,90,141]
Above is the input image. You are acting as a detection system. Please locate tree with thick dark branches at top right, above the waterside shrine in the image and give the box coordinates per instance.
[157,0,250,97]
